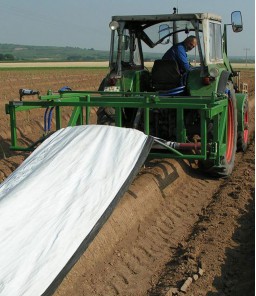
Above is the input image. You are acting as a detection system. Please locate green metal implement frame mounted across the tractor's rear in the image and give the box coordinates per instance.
[6,91,228,165]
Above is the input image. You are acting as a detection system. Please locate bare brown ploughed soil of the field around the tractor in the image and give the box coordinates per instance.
[0,69,255,296]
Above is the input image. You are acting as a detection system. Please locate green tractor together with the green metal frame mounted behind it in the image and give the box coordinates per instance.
[6,11,248,177]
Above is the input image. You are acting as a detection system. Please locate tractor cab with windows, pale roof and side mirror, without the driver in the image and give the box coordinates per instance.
[102,12,242,96]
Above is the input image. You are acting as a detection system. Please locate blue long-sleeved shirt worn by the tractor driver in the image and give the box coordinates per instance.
[162,42,191,74]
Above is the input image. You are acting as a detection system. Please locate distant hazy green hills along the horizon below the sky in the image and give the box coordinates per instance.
[0,44,254,63]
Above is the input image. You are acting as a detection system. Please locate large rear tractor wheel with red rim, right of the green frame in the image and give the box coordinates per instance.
[200,84,237,177]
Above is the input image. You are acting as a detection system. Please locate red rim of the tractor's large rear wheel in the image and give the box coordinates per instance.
[226,99,235,162]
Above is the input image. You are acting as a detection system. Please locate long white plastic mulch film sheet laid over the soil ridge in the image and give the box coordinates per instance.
[0,125,151,296]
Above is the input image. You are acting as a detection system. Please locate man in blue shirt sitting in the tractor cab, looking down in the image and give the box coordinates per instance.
[162,36,197,74]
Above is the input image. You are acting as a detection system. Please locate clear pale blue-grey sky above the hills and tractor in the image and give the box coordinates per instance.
[0,0,255,56]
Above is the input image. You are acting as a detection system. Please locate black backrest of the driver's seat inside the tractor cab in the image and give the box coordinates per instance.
[152,60,182,91]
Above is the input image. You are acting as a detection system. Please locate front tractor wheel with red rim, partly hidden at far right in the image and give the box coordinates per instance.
[237,98,249,152]
